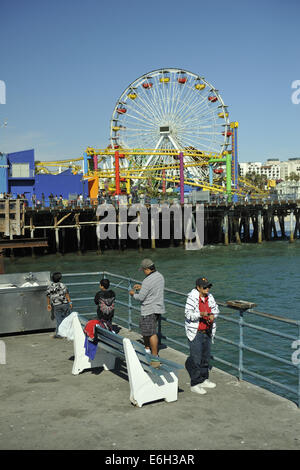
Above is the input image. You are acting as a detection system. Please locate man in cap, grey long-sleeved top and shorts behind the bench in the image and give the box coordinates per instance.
[129,258,165,367]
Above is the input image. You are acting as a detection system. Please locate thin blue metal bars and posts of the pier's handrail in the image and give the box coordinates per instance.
[64,271,300,407]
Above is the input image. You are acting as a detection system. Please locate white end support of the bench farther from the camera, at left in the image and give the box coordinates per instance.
[72,316,116,375]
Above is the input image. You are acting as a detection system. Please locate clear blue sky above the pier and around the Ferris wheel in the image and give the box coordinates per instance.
[0,0,300,162]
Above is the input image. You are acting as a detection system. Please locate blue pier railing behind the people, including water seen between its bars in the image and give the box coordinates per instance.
[64,271,300,407]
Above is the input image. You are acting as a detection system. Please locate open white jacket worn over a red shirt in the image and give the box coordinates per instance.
[184,288,219,341]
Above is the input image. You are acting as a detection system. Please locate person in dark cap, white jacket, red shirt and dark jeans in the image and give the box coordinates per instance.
[185,277,219,395]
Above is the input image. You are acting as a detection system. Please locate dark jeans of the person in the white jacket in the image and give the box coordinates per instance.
[185,331,211,387]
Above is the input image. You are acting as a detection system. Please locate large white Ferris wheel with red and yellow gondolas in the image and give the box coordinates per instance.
[110,68,231,176]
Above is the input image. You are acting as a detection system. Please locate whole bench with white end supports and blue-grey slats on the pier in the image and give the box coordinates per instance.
[72,314,184,407]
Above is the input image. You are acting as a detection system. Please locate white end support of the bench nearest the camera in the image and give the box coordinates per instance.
[123,338,178,407]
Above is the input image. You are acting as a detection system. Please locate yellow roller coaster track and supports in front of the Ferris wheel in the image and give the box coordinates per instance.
[84,147,268,198]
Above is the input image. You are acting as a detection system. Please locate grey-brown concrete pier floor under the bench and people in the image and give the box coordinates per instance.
[0,329,300,452]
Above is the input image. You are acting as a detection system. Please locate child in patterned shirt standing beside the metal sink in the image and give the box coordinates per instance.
[46,272,72,338]
